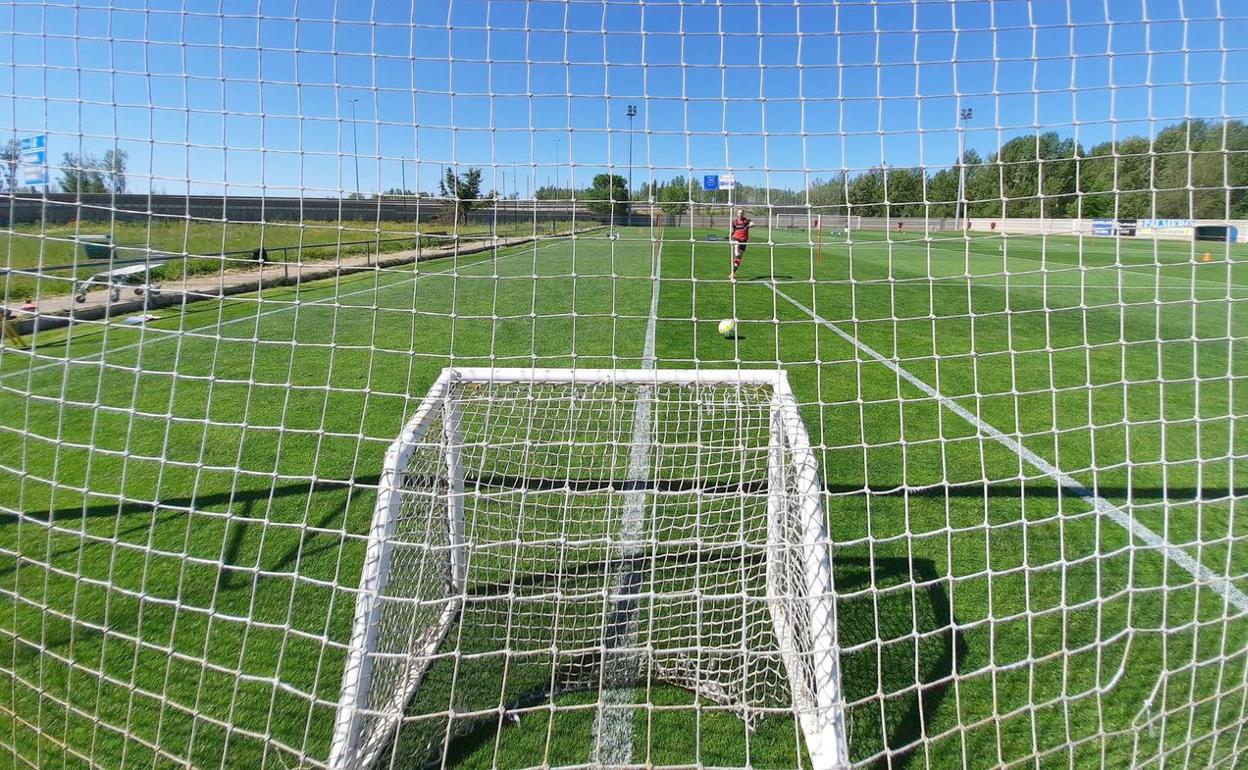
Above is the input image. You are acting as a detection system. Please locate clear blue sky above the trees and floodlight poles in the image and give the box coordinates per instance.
[0,0,1248,195]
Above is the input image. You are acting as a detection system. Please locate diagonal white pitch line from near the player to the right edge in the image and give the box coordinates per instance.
[771,286,1248,612]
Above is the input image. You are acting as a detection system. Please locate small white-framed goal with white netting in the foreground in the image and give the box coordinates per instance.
[329,368,849,770]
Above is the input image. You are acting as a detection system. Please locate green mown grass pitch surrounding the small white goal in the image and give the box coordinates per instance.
[0,228,1248,768]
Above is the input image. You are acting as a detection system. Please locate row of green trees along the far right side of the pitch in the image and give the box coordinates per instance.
[537,120,1248,220]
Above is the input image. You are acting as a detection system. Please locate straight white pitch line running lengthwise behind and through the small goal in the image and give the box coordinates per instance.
[594,240,663,768]
